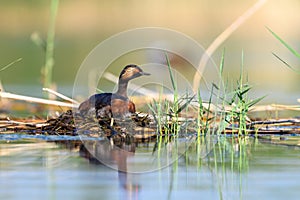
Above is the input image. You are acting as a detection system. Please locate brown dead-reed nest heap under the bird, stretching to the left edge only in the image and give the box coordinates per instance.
[0,109,156,142]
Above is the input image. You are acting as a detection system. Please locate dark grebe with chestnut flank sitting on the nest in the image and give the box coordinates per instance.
[78,64,150,117]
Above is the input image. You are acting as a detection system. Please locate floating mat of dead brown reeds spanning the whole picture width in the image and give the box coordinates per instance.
[0,110,300,141]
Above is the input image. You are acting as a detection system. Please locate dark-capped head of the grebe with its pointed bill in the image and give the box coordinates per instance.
[119,64,150,81]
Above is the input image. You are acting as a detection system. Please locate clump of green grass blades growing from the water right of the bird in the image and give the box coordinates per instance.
[148,51,265,138]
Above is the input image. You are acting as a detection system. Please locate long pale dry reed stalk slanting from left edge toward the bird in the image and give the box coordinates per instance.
[0,92,78,108]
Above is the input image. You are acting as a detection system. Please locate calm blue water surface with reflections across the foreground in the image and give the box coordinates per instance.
[0,136,300,200]
